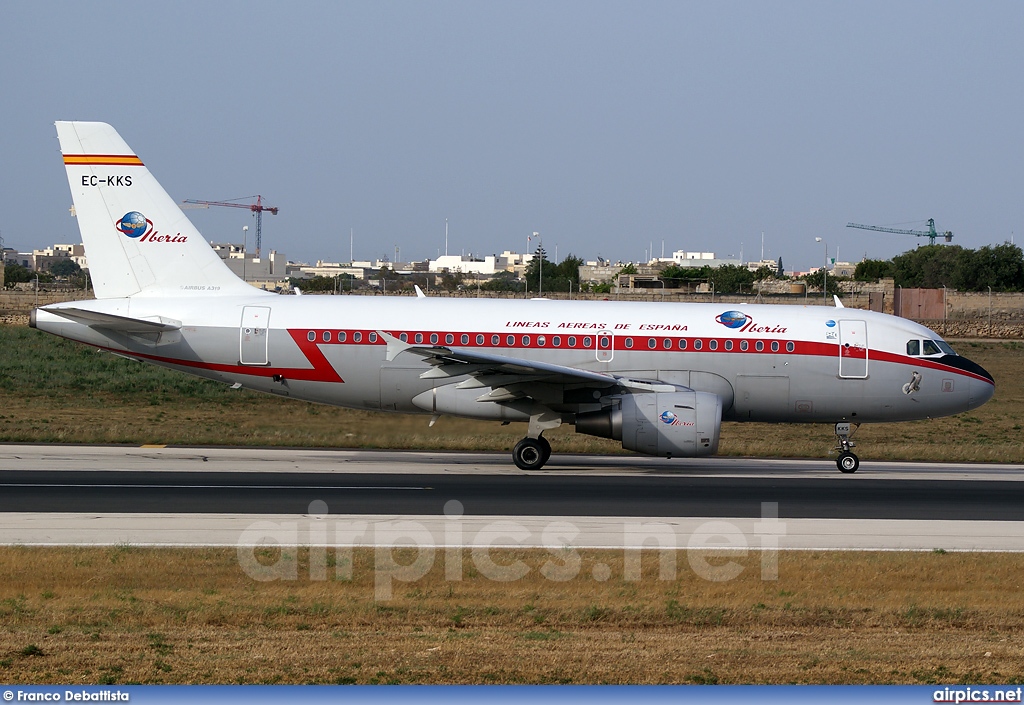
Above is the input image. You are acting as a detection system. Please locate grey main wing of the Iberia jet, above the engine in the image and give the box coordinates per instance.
[378,331,680,402]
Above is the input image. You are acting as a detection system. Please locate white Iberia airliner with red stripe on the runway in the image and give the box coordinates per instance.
[31,122,995,473]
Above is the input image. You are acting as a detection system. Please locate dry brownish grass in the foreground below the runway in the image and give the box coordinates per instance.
[0,546,1024,683]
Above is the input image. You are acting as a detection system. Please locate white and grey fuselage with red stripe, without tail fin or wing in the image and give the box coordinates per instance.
[35,292,993,422]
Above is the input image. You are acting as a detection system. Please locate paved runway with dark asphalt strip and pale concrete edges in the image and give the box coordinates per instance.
[0,446,1024,550]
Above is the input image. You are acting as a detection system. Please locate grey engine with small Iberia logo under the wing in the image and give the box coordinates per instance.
[575,391,722,458]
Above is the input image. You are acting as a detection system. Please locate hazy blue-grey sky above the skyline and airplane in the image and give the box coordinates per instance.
[0,1,1024,268]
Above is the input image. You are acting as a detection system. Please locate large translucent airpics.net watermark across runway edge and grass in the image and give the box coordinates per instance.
[237,499,786,600]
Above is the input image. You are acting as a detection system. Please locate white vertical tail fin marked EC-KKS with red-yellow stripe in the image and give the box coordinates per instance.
[56,122,257,298]
